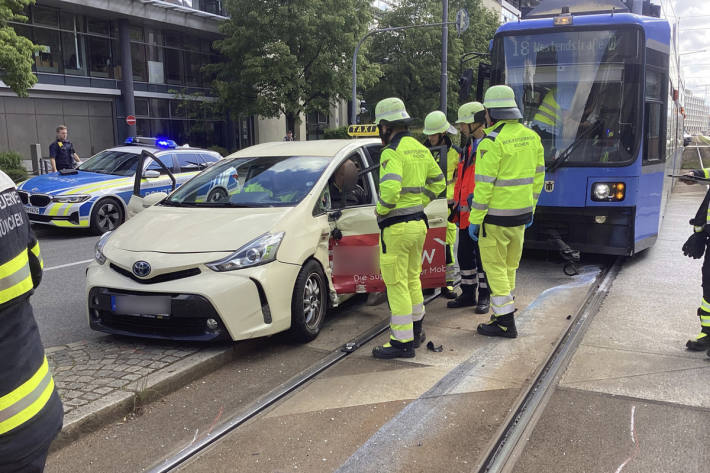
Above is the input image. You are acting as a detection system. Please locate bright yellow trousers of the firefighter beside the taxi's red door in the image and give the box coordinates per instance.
[380,220,427,342]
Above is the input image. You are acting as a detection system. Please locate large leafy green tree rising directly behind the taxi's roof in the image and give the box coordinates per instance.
[212,0,379,131]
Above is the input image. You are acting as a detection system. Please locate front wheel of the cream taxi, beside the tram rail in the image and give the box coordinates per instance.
[291,260,328,342]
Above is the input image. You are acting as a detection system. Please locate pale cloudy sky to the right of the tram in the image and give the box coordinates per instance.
[672,0,710,99]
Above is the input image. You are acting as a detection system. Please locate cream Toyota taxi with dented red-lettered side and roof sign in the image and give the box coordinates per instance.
[86,138,447,341]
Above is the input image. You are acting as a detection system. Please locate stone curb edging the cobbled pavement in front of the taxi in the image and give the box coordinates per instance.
[50,346,234,452]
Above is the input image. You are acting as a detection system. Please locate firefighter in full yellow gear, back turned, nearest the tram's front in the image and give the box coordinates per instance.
[468,85,545,338]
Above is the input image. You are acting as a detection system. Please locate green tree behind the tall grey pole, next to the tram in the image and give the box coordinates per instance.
[364,0,499,121]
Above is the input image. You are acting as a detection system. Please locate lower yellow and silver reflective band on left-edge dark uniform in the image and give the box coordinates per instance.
[0,357,54,435]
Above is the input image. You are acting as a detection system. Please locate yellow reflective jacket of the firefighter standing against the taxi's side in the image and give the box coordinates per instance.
[377,132,446,222]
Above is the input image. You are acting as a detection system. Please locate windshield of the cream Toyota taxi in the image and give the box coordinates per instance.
[163,156,329,207]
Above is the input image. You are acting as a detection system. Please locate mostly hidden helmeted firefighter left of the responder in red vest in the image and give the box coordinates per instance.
[422,110,468,299]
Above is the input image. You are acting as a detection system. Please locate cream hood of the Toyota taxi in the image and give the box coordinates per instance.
[106,205,291,253]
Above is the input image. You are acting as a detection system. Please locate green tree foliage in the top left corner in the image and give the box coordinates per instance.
[0,0,40,97]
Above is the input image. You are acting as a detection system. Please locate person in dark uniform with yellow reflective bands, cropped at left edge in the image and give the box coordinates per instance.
[0,171,64,473]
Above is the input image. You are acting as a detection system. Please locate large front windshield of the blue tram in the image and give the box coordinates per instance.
[493,30,642,166]
